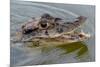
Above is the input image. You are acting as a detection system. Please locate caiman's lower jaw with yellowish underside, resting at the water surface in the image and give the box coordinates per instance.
[27,32,90,47]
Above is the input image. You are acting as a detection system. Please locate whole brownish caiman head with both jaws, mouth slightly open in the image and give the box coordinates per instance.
[13,14,90,46]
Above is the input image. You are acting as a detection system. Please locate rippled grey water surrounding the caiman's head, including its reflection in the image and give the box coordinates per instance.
[10,0,95,65]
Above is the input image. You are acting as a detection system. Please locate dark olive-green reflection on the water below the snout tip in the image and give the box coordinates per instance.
[57,42,88,57]
